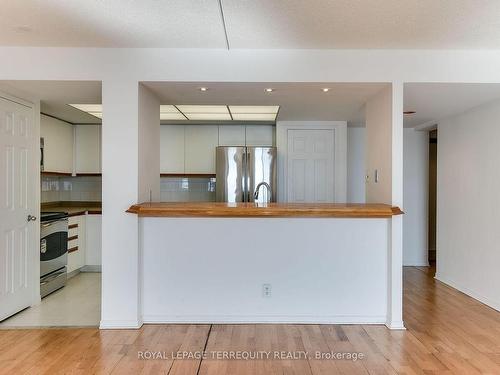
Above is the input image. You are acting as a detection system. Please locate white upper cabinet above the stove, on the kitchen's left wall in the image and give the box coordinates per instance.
[40,115,74,173]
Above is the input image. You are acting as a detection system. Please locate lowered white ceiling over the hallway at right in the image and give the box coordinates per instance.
[404,83,500,127]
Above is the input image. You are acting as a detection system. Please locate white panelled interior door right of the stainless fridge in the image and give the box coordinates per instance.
[287,129,335,203]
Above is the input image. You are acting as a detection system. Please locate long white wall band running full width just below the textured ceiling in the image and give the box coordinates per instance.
[4,47,500,83]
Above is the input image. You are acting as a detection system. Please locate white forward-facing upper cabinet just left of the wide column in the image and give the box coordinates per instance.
[75,125,101,174]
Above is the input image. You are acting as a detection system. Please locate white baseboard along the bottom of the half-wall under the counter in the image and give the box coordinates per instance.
[143,315,387,324]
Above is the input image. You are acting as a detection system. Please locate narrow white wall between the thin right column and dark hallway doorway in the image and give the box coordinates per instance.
[403,129,429,266]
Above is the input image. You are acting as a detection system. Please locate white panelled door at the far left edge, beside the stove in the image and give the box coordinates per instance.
[0,97,40,320]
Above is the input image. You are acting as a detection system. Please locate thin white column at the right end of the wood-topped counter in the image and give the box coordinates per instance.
[386,82,405,329]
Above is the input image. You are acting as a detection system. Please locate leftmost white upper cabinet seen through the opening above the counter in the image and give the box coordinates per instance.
[160,125,184,173]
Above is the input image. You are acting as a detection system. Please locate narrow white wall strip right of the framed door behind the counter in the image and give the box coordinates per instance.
[347,128,366,203]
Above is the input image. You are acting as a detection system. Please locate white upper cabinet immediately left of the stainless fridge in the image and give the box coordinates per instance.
[184,125,219,174]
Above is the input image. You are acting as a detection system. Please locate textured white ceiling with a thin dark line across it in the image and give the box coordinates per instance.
[0,0,500,49]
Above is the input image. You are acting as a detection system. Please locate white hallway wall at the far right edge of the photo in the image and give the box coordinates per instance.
[436,102,500,310]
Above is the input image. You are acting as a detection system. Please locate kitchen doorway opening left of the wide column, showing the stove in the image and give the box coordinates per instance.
[0,81,102,329]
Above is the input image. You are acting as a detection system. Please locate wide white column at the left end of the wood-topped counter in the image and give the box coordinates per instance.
[100,80,160,328]
